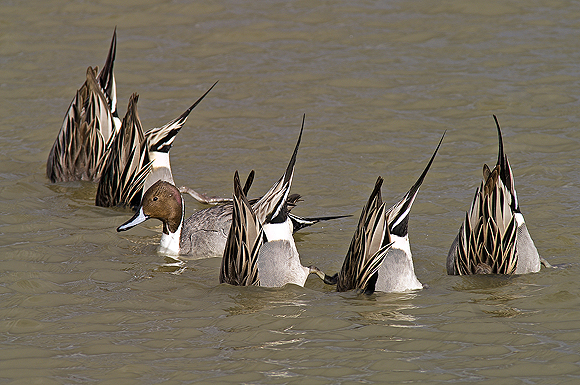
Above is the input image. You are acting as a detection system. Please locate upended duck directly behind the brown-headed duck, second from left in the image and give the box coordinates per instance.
[95,82,217,207]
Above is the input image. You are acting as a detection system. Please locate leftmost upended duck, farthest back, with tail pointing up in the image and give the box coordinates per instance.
[46,28,121,183]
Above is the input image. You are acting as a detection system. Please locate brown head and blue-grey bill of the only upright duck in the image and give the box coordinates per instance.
[117,180,183,234]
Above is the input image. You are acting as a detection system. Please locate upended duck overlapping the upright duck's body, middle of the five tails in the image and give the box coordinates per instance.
[219,121,330,287]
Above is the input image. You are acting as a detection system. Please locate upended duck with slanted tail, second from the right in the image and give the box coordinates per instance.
[333,134,445,294]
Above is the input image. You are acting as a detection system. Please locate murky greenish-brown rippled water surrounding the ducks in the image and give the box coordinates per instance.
[0,0,580,384]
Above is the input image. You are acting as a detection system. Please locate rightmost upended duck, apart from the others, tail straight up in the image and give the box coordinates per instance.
[447,115,542,275]
